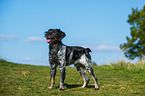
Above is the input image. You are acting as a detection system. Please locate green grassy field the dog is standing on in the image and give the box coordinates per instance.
[0,59,145,96]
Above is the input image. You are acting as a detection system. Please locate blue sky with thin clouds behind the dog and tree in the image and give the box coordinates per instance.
[0,0,145,65]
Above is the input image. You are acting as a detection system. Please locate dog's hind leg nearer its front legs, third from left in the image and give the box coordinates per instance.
[75,64,90,88]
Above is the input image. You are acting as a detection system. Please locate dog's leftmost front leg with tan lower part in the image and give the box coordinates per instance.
[47,64,57,89]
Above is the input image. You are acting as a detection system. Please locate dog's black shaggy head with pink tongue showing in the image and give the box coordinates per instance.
[45,29,65,43]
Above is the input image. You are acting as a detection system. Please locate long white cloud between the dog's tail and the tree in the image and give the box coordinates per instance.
[83,45,120,51]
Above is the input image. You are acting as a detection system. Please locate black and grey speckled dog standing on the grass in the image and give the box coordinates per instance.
[45,29,99,90]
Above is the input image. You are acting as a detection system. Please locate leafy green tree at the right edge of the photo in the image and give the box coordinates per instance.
[120,5,145,60]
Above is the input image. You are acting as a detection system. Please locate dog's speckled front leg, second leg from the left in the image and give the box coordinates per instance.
[59,66,65,90]
